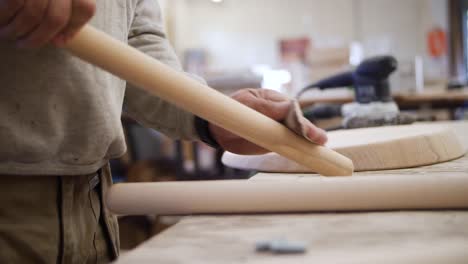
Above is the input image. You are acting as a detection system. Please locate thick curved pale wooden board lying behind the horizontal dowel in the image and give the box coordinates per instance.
[222,123,468,172]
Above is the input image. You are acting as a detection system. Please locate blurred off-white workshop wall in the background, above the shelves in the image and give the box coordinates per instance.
[163,0,448,77]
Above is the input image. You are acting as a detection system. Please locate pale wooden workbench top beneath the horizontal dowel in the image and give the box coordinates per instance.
[113,122,468,264]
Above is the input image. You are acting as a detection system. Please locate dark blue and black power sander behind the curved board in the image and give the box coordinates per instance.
[297,56,414,128]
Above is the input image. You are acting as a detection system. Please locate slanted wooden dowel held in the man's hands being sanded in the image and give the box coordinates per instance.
[66,25,353,176]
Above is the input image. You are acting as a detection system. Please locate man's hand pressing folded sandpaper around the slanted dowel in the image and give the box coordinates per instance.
[209,89,327,154]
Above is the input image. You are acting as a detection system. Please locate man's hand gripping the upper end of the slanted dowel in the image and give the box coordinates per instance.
[0,0,96,48]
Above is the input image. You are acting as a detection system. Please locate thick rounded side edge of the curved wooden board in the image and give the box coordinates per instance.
[222,126,466,173]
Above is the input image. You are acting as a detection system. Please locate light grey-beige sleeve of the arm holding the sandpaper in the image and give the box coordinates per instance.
[124,0,204,140]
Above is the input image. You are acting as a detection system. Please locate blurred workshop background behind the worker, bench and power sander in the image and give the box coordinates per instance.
[112,0,468,249]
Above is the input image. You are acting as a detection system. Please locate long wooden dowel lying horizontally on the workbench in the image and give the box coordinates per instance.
[106,175,468,215]
